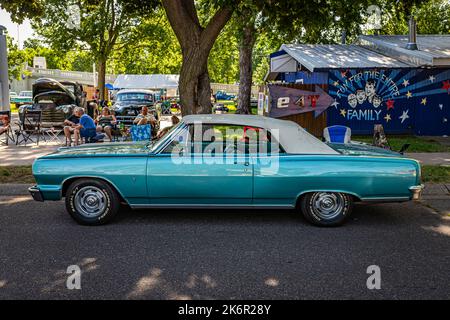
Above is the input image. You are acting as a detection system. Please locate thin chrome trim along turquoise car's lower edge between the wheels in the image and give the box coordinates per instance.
[130,204,295,209]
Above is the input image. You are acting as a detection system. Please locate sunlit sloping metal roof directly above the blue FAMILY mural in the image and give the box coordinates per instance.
[280,44,413,72]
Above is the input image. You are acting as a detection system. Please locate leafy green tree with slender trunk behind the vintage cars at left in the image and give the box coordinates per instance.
[32,0,155,99]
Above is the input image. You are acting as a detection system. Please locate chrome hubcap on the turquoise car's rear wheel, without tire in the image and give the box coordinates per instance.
[311,192,345,220]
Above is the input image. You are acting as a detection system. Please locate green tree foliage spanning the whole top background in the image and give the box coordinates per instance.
[0,0,450,109]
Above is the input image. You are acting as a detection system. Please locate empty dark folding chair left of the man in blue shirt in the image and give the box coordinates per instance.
[16,109,42,146]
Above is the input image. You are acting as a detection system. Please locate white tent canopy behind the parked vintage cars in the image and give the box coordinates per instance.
[113,74,180,89]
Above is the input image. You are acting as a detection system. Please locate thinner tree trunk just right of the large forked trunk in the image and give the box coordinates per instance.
[236,22,256,114]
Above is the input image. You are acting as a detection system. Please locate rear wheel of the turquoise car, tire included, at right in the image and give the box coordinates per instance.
[301,192,353,227]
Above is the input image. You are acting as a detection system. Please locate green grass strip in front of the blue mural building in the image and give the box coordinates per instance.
[352,136,450,152]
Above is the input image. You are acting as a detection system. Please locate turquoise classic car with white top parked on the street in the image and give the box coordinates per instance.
[29,115,423,226]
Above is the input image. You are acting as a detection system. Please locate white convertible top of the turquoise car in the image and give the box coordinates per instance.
[182,114,339,154]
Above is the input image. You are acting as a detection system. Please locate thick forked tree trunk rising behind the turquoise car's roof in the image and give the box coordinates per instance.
[162,0,233,115]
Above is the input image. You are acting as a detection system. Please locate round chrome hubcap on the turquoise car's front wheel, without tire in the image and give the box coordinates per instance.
[74,186,106,218]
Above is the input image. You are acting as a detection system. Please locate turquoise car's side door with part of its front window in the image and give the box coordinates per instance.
[147,125,253,207]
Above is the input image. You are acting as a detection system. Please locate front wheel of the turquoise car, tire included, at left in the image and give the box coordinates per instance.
[66,179,120,225]
